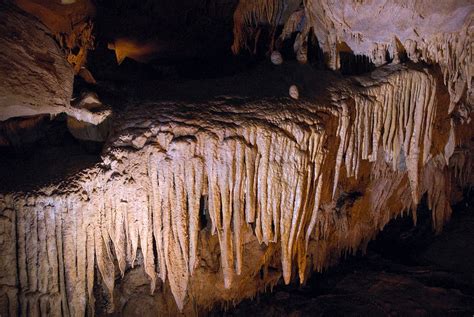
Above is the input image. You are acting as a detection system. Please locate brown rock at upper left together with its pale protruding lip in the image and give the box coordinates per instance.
[0,3,111,146]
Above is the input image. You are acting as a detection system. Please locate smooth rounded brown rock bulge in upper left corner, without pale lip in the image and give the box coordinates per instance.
[0,4,74,120]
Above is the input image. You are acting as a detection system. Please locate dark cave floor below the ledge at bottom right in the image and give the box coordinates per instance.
[215,195,474,316]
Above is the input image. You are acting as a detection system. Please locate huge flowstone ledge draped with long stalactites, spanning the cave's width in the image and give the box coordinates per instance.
[0,61,472,316]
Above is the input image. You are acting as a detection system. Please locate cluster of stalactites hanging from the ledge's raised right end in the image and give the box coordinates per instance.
[333,67,436,203]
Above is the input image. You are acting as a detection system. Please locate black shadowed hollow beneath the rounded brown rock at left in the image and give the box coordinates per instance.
[0,115,103,192]
